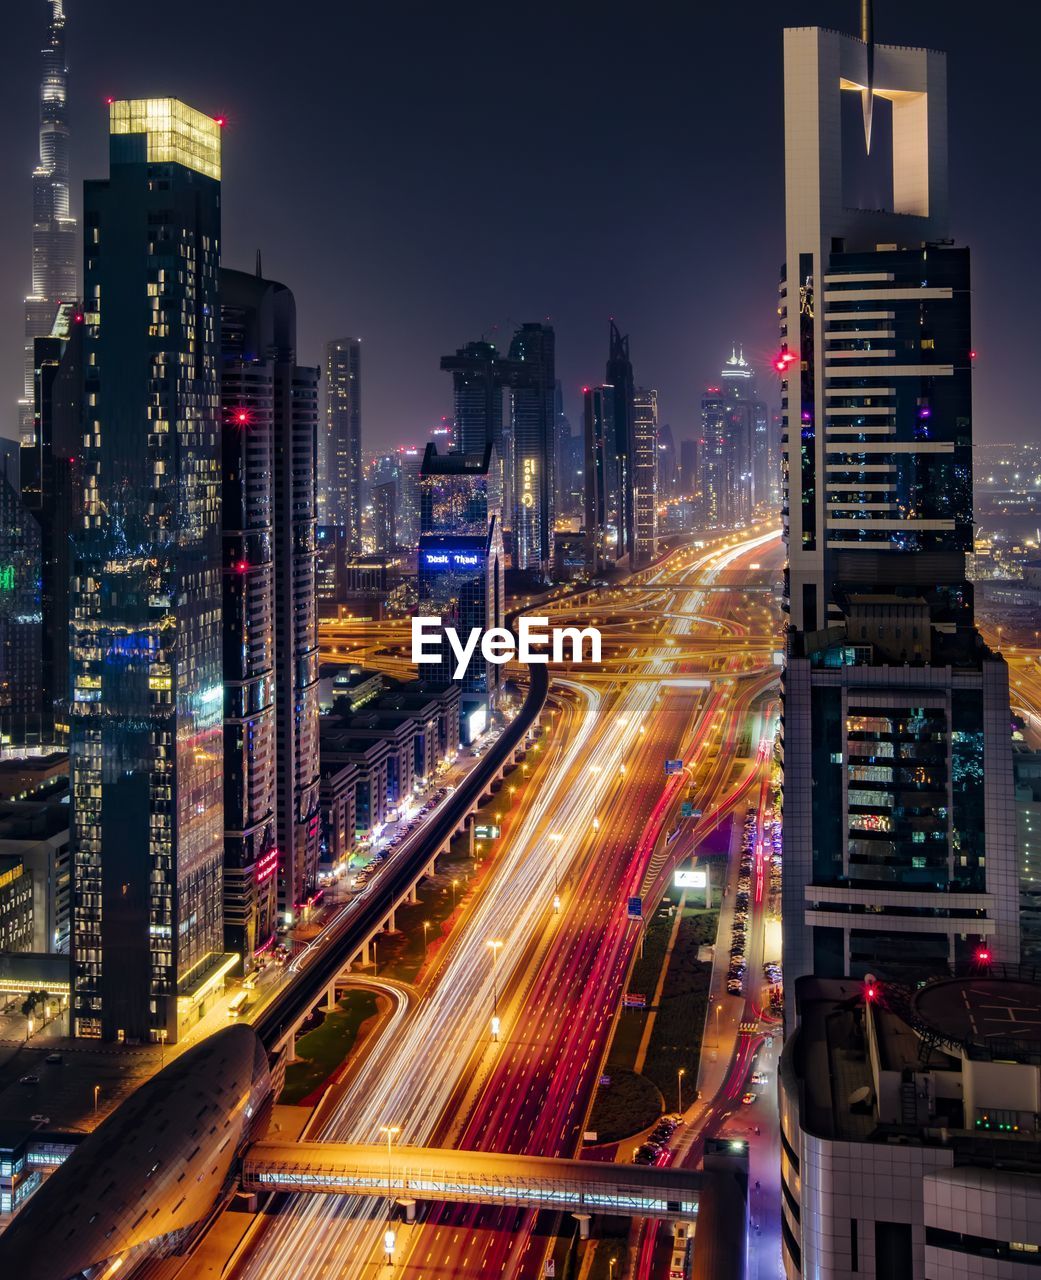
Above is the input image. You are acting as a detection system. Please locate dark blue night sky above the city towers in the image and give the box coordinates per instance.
[0,0,1041,451]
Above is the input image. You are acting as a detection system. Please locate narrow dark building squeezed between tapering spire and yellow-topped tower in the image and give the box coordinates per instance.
[19,302,83,737]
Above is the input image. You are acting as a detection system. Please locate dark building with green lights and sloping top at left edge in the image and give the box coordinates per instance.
[0,471,44,742]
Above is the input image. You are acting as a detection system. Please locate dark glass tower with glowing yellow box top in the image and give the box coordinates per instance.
[70,99,227,1043]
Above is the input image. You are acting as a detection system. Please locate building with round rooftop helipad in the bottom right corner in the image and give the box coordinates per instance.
[777,968,1041,1280]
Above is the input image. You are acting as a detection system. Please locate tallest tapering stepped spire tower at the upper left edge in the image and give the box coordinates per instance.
[18,0,78,444]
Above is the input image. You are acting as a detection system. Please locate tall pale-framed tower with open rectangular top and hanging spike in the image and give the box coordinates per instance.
[777,28,1019,1028]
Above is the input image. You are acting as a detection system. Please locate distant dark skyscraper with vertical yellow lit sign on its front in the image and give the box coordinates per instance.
[507,324,557,579]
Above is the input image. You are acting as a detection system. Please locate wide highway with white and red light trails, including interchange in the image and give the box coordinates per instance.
[208,530,776,1280]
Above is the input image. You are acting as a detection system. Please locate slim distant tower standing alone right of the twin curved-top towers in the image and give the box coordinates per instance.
[325,338,361,556]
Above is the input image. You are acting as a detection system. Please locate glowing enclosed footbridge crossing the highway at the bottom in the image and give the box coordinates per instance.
[242,1142,717,1234]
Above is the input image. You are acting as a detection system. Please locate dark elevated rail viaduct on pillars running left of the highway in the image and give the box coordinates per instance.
[254,664,549,1057]
